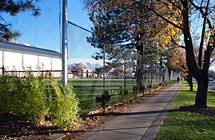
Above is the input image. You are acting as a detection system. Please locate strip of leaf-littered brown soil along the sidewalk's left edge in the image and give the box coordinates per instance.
[0,85,171,140]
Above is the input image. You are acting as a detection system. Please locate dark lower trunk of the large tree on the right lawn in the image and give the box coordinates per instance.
[195,76,208,108]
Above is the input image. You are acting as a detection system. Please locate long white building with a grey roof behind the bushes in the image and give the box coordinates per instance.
[0,41,62,77]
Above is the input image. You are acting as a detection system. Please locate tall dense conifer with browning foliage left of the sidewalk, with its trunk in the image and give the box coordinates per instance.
[84,0,180,90]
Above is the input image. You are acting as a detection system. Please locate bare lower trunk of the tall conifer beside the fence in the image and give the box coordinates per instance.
[136,54,143,91]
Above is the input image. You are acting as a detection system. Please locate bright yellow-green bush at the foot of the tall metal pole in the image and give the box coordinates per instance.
[48,78,79,127]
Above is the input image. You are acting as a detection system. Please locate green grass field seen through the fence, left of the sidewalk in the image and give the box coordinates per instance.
[68,79,136,114]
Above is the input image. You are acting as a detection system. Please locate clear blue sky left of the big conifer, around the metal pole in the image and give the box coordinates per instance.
[1,0,96,58]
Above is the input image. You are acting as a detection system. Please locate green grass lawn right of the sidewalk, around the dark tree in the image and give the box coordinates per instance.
[155,82,215,140]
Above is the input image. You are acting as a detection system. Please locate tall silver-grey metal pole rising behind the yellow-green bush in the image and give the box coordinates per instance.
[62,0,68,86]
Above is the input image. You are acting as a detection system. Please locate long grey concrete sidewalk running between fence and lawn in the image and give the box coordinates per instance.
[78,82,182,140]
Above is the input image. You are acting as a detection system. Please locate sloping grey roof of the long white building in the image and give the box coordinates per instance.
[0,41,62,58]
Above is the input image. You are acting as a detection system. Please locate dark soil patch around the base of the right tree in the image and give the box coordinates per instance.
[179,105,215,116]
